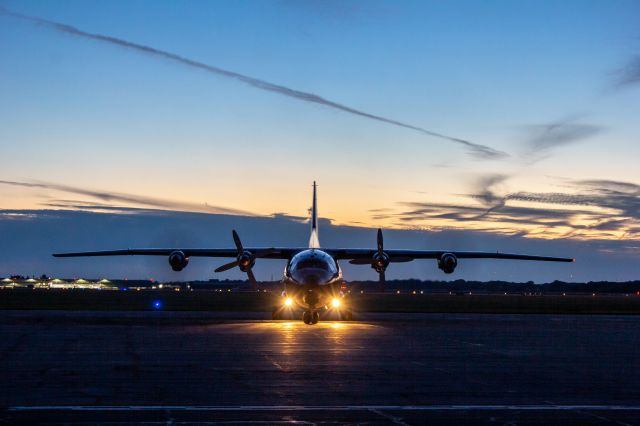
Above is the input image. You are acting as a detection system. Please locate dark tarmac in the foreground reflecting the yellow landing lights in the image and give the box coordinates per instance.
[0,311,640,424]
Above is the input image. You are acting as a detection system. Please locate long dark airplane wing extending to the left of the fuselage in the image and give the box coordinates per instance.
[53,247,304,259]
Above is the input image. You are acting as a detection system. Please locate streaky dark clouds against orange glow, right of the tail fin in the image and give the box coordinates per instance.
[384,175,640,240]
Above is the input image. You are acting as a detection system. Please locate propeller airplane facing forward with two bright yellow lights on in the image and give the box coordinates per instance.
[53,182,574,324]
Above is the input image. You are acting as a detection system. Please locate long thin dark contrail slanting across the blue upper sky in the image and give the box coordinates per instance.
[0,7,508,159]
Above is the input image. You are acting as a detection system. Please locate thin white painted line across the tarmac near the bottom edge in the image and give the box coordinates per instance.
[9,405,640,412]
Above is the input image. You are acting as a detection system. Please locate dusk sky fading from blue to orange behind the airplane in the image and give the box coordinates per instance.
[0,0,640,281]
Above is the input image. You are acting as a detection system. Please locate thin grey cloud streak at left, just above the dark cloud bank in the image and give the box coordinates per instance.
[0,180,255,216]
